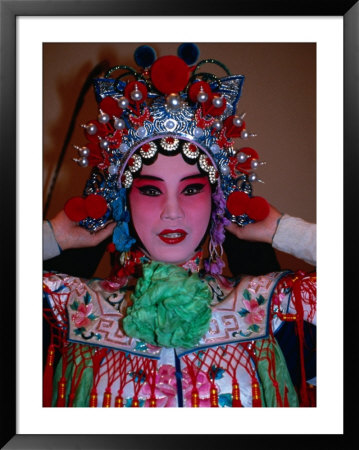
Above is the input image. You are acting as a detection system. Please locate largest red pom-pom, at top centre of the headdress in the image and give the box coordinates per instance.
[151,55,191,94]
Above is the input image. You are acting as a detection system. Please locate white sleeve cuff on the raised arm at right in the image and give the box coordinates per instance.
[272,214,317,266]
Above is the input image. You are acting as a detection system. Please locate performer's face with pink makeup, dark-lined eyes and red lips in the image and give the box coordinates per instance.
[129,154,212,264]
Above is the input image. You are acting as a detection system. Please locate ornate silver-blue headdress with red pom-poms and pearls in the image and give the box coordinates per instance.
[65,44,269,274]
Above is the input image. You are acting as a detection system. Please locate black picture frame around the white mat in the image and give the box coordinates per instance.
[0,0,359,449]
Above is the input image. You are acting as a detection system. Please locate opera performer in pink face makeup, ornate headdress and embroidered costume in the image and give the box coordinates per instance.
[44,47,315,407]
